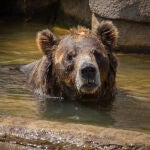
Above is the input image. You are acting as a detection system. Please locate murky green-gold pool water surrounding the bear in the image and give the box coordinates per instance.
[0,22,150,132]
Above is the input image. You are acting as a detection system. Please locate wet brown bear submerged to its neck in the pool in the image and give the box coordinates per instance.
[21,21,118,101]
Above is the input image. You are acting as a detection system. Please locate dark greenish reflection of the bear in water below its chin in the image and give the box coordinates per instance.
[39,96,114,126]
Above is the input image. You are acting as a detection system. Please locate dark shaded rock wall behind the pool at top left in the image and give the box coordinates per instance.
[0,0,91,26]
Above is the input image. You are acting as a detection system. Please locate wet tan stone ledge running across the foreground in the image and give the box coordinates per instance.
[0,117,150,150]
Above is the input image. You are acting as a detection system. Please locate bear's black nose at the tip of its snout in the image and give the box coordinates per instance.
[81,64,96,79]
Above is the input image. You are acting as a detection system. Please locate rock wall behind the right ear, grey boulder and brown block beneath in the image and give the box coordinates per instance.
[89,0,150,52]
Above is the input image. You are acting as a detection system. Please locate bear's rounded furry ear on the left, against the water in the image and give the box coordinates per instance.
[36,29,57,56]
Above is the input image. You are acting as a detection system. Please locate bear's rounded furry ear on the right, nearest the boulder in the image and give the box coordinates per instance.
[96,21,118,49]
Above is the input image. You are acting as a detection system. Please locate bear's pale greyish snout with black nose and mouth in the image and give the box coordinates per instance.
[75,54,101,94]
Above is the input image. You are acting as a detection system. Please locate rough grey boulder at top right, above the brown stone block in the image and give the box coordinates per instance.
[89,0,150,22]
